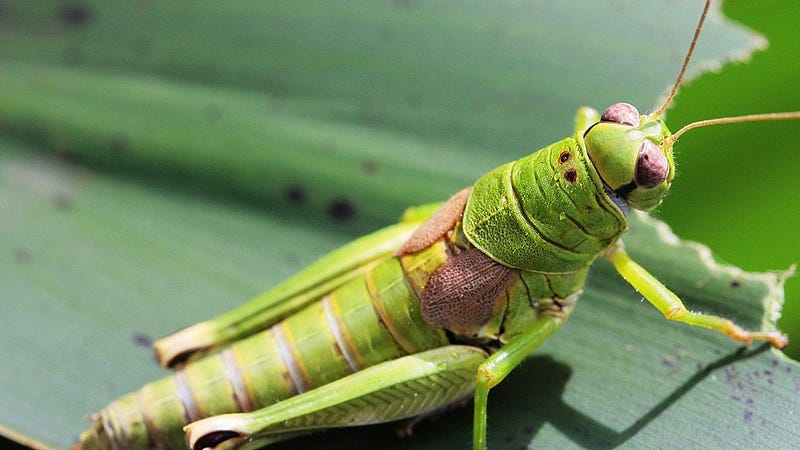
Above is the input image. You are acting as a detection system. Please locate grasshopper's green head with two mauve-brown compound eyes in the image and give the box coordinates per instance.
[583,103,675,211]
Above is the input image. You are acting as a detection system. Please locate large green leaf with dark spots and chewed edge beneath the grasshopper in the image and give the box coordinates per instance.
[0,1,800,448]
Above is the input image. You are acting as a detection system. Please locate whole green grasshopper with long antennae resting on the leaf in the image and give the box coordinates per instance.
[73,0,800,450]
